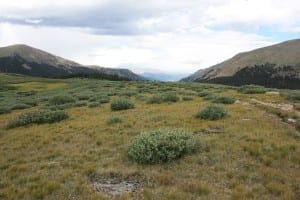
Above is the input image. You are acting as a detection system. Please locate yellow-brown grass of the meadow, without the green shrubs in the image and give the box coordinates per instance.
[0,76,300,199]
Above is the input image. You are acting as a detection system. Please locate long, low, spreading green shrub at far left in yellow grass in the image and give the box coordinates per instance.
[6,110,69,129]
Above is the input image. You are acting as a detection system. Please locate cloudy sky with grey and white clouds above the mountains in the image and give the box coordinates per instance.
[0,0,300,73]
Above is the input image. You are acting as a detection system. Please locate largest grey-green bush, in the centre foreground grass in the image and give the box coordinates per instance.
[127,129,197,164]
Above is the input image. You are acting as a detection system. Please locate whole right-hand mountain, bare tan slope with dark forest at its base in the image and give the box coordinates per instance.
[182,39,300,89]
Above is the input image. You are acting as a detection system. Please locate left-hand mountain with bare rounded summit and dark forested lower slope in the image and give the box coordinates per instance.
[0,45,142,80]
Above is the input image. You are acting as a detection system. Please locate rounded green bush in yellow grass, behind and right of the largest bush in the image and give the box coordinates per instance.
[196,105,227,120]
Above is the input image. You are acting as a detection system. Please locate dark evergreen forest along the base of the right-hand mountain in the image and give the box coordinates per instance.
[195,63,300,89]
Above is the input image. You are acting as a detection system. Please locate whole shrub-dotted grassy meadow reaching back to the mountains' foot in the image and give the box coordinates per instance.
[0,74,300,200]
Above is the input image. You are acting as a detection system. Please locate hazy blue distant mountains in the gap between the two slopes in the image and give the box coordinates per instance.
[140,72,187,81]
